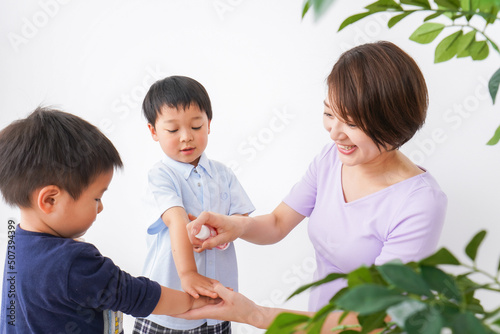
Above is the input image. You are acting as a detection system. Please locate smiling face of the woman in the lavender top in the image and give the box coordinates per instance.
[323,97,387,166]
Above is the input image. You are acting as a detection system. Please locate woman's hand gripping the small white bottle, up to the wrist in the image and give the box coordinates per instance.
[186,211,245,253]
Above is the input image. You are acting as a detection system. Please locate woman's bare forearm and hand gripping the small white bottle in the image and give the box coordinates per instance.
[187,202,304,252]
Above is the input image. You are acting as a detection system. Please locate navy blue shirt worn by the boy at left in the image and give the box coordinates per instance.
[0,226,161,334]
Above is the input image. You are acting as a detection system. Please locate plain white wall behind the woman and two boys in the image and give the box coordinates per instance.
[0,0,500,333]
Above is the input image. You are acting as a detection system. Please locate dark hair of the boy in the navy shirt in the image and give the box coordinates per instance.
[0,107,123,208]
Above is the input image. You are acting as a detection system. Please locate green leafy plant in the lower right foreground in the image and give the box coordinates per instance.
[267,231,500,334]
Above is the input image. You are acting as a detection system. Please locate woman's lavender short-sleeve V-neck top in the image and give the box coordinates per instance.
[283,143,447,311]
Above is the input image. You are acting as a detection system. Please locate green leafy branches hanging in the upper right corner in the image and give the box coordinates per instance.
[302,0,500,145]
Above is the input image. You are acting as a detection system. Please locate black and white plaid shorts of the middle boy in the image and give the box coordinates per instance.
[132,318,231,334]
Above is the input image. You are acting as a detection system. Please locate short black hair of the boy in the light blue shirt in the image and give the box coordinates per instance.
[142,76,212,126]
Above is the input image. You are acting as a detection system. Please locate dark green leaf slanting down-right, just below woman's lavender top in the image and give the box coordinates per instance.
[377,263,433,298]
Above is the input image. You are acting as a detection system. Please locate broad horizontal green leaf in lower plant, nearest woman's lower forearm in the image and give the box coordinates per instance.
[336,284,408,315]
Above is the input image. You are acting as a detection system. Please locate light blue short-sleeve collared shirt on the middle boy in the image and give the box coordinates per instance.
[144,153,255,330]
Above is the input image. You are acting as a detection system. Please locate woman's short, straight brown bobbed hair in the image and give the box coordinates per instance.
[327,41,429,149]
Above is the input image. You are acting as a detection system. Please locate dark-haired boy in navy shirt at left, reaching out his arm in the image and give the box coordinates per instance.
[0,108,213,334]
